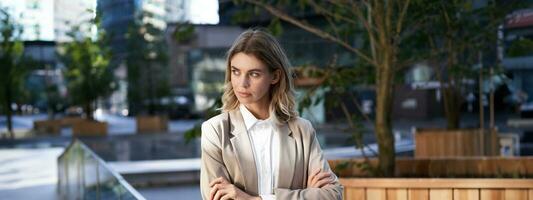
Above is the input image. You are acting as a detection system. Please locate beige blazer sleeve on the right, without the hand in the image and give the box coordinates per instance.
[274,122,343,200]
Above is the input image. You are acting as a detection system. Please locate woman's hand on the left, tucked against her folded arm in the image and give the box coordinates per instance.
[209,177,261,200]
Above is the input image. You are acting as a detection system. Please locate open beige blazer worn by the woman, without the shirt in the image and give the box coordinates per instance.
[200,109,343,200]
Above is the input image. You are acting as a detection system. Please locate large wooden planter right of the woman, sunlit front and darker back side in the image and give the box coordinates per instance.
[329,157,533,200]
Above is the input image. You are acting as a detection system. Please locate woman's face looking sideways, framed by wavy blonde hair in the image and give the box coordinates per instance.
[230,53,279,106]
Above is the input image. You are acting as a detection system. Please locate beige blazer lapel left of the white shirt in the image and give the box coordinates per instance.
[229,109,258,195]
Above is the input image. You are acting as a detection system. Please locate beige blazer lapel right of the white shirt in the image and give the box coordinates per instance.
[277,122,296,188]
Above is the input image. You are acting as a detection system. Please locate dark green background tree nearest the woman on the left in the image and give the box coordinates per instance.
[126,12,170,115]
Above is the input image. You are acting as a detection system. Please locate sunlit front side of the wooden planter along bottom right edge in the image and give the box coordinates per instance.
[340,178,533,200]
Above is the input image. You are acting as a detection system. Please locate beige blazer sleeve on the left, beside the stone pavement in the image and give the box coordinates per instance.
[200,121,230,200]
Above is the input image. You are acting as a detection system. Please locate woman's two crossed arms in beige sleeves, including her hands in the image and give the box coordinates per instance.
[200,120,342,200]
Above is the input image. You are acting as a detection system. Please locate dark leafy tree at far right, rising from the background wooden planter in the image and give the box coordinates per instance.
[418,0,516,129]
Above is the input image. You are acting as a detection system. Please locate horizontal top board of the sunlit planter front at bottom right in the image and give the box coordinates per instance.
[339,178,533,189]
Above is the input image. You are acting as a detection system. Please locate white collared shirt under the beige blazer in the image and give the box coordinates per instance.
[239,104,279,200]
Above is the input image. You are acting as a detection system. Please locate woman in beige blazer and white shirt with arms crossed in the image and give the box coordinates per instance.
[200,30,343,200]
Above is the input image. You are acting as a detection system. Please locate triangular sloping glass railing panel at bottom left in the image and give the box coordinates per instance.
[58,140,144,200]
